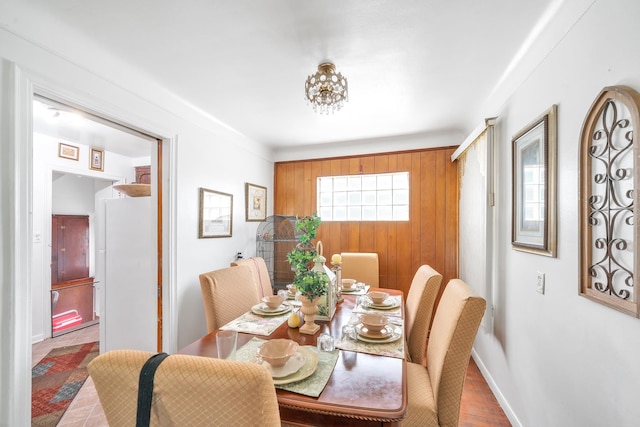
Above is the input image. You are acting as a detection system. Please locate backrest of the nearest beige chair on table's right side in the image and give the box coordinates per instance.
[427,279,486,426]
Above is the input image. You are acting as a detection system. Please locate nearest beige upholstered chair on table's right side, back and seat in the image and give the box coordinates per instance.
[402,279,486,427]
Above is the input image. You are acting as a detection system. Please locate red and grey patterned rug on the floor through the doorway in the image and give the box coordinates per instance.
[31,342,100,426]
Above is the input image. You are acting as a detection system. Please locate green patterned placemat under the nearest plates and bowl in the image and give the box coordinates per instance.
[236,337,338,397]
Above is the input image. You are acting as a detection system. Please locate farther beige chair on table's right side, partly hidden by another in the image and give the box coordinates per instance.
[404,265,442,363]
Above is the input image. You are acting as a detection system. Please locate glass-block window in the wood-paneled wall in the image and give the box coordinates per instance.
[317,172,409,222]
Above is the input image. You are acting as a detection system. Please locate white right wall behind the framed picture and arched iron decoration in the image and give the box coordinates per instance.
[475,0,640,427]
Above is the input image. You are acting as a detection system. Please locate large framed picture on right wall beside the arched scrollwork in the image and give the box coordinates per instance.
[511,105,557,257]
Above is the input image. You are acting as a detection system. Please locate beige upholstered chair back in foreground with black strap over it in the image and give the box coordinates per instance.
[88,350,280,426]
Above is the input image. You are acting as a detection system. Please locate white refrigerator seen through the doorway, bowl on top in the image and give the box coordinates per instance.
[100,197,158,353]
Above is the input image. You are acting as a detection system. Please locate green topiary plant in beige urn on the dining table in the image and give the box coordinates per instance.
[287,213,329,334]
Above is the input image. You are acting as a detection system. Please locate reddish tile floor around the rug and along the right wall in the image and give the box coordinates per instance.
[31,325,511,427]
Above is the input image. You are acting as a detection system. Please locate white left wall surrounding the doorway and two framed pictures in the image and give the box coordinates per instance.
[0,20,273,425]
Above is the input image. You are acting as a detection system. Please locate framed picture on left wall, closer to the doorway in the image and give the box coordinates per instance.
[198,188,233,239]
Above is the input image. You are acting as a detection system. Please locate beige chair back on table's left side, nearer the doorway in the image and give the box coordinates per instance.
[200,265,260,332]
